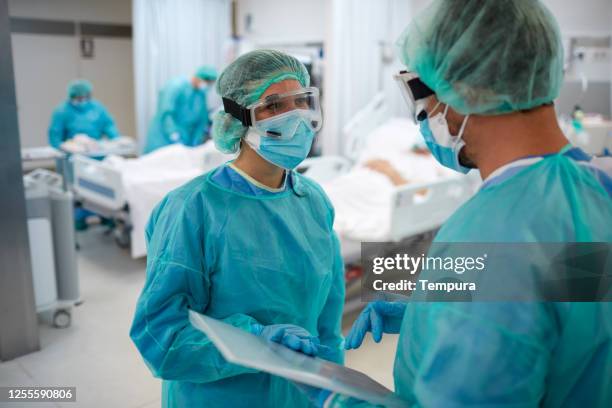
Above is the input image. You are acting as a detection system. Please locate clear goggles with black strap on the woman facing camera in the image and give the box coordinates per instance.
[223,88,323,137]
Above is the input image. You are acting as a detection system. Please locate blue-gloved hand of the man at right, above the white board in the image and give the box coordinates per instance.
[344,301,406,350]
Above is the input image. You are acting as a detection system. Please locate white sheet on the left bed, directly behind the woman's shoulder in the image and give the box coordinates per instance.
[105,141,232,258]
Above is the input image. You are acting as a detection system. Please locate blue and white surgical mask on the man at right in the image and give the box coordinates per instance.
[420,102,471,174]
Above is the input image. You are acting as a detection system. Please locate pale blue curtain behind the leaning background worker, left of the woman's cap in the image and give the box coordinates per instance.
[132,0,231,151]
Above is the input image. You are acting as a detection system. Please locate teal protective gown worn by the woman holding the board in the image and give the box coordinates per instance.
[130,166,344,407]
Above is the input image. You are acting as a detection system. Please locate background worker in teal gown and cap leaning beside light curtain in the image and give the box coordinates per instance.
[144,66,217,153]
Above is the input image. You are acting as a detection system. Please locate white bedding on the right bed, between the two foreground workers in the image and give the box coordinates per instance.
[322,118,457,242]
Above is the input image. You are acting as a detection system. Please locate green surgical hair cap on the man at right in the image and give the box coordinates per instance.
[397,0,563,115]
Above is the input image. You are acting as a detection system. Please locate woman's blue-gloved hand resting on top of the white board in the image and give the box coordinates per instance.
[253,324,320,356]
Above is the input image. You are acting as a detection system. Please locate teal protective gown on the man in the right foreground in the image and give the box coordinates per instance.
[331,149,612,408]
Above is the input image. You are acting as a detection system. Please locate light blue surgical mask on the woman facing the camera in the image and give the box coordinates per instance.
[245,109,315,170]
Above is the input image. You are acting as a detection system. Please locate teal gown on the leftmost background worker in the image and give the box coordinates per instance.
[49,100,119,149]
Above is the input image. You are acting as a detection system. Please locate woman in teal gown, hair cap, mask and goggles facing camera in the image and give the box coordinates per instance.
[130,50,344,407]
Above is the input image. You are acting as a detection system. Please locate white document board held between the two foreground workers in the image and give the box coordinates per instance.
[189,311,408,407]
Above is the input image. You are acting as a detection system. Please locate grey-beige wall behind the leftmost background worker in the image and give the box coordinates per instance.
[9,0,135,147]
